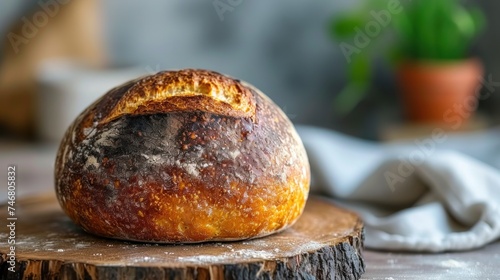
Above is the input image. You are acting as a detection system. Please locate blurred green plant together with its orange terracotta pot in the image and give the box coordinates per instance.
[332,0,484,123]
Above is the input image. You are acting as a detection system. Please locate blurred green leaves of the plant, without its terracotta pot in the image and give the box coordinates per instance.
[330,0,485,114]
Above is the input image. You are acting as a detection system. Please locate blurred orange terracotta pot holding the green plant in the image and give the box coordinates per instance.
[398,59,483,124]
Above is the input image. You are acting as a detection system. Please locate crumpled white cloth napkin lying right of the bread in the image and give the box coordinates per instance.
[297,126,500,252]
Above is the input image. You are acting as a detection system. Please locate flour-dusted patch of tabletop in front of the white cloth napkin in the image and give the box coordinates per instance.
[361,241,500,280]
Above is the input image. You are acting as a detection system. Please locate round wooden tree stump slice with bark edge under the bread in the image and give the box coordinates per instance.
[0,195,365,279]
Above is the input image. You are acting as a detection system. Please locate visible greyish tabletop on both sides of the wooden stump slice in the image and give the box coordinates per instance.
[0,144,500,280]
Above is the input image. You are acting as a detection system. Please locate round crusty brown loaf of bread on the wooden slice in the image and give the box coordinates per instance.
[55,69,310,243]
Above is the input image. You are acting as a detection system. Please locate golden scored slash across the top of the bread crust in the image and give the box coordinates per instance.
[101,69,255,123]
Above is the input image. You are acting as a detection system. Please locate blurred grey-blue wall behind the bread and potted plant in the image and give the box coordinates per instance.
[0,0,500,137]
